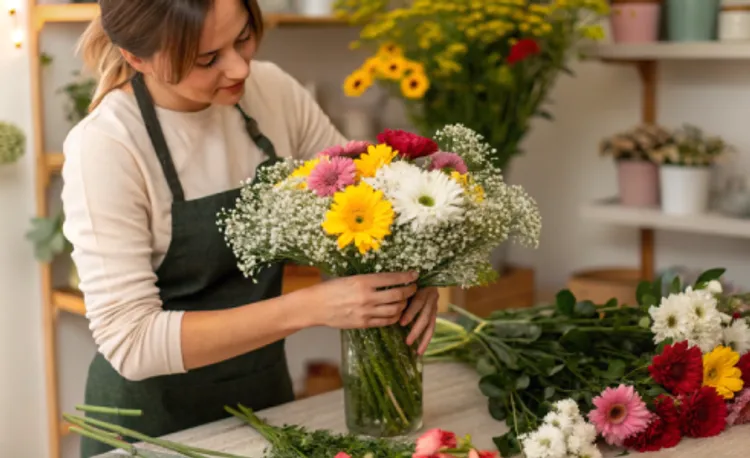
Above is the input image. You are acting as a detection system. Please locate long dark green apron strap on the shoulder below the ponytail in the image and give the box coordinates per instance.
[131,72,185,202]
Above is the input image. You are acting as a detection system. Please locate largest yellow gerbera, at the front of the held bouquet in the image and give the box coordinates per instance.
[322,183,394,254]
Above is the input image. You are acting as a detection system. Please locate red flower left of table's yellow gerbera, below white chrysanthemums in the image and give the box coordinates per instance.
[648,341,703,394]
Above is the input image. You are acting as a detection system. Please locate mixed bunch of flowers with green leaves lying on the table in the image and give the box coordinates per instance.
[428,269,750,458]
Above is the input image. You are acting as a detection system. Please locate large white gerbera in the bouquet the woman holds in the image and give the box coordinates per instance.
[389,170,465,231]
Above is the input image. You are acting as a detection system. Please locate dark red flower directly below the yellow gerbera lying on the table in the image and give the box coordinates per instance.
[680,386,727,437]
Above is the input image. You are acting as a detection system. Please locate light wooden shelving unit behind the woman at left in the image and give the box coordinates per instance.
[26,0,348,458]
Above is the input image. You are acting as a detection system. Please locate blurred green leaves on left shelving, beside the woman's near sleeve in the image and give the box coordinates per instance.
[26,211,79,289]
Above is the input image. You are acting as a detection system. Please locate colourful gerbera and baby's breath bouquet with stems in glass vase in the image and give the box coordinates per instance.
[219,125,541,436]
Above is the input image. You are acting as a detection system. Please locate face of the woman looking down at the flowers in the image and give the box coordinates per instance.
[145,0,257,110]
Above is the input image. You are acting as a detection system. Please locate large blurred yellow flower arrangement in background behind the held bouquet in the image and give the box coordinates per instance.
[335,0,609,271]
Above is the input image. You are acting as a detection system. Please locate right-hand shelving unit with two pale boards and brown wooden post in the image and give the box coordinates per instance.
[581,42,750,280]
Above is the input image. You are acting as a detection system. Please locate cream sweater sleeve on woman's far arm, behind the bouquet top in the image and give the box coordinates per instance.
[274,64,347,159]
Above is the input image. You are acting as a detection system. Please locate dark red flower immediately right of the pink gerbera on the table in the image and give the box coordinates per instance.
[623,396,682,453]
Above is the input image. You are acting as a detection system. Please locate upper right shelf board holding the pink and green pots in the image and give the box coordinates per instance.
[582,41,750,61]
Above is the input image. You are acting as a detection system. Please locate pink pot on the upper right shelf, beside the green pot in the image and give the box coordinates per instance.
[610,0,661,43]
